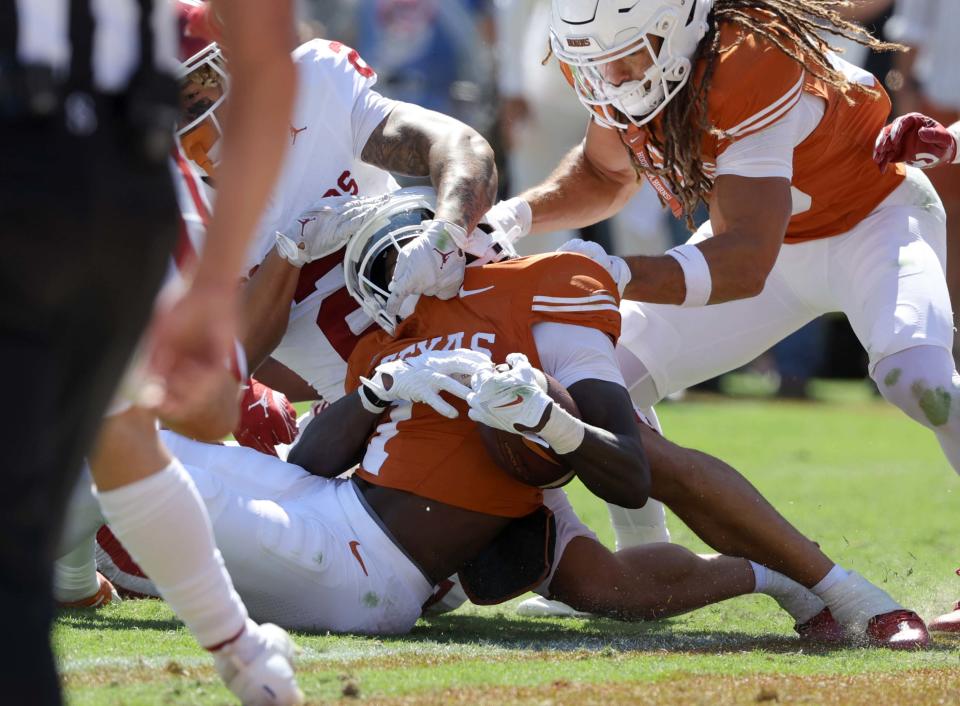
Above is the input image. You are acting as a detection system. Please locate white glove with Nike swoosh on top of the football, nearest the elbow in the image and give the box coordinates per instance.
[467,353,585,454]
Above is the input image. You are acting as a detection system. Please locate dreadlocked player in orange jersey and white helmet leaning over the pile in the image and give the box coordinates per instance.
[394,0,960,628]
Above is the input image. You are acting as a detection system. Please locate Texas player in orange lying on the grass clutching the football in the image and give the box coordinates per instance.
[65,190,927,647]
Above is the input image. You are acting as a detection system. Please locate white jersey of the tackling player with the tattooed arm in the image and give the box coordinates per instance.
[247,39,399,402]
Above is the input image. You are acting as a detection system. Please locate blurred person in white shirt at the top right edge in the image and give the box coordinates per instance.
[886,0,960,357]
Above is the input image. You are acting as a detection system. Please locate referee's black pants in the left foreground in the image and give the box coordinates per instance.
[0,102,178,706]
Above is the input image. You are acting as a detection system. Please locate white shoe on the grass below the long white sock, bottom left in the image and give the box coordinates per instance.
[213,620,303,706]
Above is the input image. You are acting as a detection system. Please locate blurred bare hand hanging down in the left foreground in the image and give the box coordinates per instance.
[147,279,239,428]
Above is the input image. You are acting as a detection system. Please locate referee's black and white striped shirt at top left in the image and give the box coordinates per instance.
[0,0,178,94]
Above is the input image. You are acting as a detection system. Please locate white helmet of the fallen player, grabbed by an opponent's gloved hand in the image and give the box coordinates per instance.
[343,186,517,334]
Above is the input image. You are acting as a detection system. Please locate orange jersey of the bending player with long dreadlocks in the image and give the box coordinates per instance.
[620,11,904,243]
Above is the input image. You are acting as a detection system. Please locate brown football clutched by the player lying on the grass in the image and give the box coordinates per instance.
[477,375,580,488]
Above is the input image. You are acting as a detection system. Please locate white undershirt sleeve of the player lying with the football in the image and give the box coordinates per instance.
[532,321,626,387]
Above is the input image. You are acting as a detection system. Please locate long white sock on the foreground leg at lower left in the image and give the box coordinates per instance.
[98,459,247,647]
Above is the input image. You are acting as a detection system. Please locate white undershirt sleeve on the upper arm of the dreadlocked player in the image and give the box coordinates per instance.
[715,93,826,179]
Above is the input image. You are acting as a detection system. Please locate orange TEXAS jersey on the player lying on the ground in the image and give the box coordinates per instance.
[345,253,620,517]
